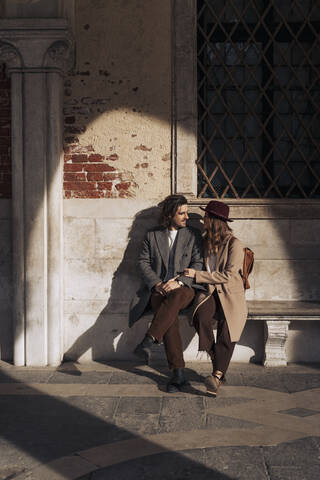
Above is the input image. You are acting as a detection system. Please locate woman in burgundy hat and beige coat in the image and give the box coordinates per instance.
[184,200,248,396]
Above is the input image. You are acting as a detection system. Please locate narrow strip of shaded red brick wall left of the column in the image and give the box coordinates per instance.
[0,64,11,198]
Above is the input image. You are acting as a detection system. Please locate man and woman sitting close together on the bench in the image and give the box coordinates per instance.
[129,195,247,395]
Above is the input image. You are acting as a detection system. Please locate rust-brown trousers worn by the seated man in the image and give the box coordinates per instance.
[147,287,195,368]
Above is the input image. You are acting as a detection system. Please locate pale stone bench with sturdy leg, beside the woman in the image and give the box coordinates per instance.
[248,300,320,367]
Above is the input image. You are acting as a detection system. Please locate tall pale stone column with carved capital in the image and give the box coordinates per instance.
[0,19,73,365]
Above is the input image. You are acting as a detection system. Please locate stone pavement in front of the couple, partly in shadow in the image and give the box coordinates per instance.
[0,362,320,480]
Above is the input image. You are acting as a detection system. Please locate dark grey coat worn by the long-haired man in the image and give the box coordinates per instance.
[129,227,203,327]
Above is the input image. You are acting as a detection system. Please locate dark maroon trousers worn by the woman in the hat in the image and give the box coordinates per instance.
[193,292,236,374]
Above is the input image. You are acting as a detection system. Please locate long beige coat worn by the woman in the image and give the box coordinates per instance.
[192,234,248,342]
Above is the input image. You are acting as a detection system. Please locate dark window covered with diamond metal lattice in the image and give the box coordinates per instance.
[197,0,320,198]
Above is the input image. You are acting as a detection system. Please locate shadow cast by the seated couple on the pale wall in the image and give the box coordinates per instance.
[64,207,263,364]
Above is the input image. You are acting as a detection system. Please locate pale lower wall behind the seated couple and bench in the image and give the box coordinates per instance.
[64,199,320,362]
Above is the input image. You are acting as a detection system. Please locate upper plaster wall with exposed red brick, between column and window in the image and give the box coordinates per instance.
[64,0,171,199]
